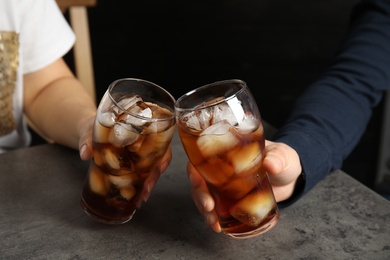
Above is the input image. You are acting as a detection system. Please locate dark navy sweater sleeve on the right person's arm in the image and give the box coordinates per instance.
[274,0,390,204]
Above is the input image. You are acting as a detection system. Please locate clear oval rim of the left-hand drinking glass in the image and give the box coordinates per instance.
[108,78,176,122]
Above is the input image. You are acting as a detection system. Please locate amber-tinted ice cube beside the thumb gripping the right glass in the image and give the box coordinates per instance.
[228,142,262,173]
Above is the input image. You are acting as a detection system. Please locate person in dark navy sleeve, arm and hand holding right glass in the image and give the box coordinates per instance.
[188,0,390,232]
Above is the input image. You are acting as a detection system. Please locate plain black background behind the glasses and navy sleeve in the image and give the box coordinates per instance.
[49,0,382,193]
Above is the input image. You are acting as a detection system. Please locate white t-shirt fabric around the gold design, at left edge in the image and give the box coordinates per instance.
[0,0,75,152]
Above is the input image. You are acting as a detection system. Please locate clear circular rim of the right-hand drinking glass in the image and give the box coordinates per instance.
[175,79,247,112]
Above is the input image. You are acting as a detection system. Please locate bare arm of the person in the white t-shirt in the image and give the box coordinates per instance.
[23,59,96,157]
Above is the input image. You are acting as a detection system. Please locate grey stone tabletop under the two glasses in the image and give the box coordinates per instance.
[0,135,390,260]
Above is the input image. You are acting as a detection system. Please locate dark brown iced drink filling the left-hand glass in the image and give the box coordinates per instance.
[81,97,175,224]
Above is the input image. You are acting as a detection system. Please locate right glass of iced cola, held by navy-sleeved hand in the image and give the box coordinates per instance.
[175,80,279,238]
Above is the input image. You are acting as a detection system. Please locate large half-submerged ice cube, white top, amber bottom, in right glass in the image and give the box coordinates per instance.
[196,122,238,158]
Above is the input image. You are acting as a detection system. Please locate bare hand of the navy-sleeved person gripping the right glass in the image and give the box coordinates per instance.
[187,141,302,233]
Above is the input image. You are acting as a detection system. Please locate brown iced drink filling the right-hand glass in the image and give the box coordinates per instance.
[178,122,279,237]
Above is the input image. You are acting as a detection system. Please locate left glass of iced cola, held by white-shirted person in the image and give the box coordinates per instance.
[81,78,175,224]
